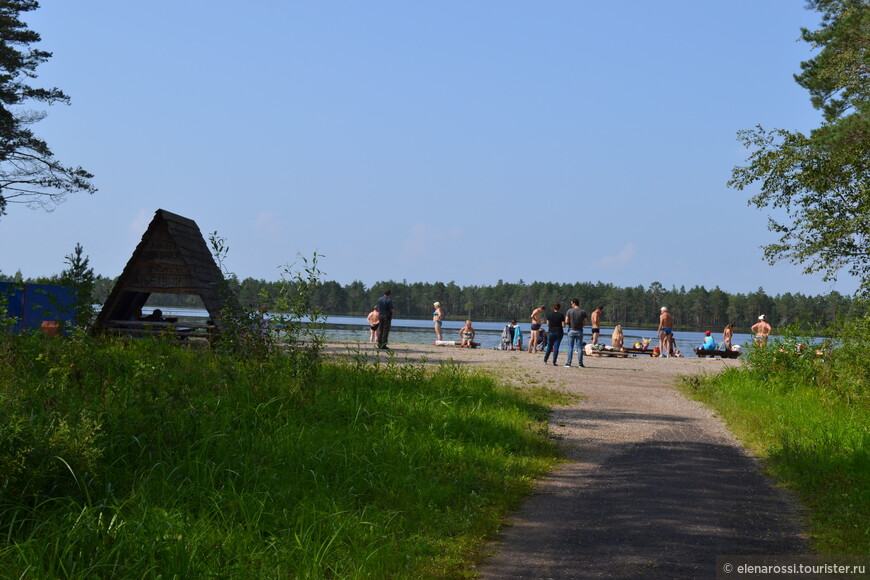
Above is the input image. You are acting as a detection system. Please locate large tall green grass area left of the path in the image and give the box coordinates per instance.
[0,336,557,578]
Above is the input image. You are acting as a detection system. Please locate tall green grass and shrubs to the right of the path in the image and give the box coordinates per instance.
[686,319,870,554]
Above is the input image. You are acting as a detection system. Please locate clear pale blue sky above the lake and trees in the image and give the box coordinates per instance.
[0,0,857,295]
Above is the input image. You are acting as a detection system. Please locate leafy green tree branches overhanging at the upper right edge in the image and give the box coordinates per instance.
[729,0,870,293]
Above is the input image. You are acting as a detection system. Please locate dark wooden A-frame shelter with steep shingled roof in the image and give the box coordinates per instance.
[93,209,240,333]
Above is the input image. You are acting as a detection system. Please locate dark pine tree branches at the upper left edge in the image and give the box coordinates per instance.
[0,0,96,216]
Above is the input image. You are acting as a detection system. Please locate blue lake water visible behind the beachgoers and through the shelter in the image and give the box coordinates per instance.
[143,307,752,357]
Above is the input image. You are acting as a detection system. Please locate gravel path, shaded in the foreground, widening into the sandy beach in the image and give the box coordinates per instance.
[324,345,809,580]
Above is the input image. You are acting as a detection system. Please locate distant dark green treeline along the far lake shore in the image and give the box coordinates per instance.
[0,275,867,332]
